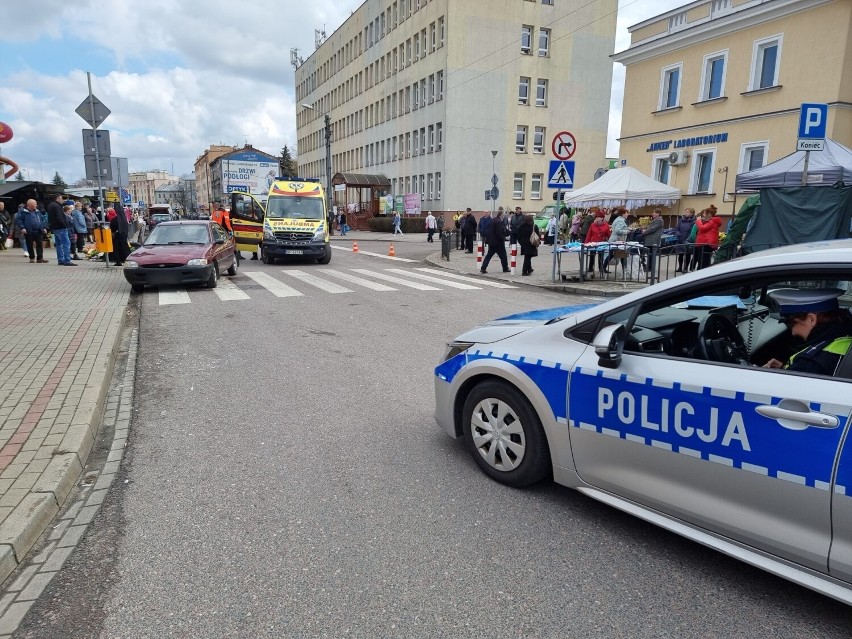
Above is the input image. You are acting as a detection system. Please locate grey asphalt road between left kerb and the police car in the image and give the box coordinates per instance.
[16,245,852,639]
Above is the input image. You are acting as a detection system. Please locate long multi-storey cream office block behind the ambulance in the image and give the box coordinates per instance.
[296,0,617,211]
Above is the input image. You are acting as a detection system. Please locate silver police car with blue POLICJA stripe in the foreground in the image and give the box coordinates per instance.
[435,240,852,604]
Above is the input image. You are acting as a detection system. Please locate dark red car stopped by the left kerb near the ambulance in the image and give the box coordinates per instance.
[124,220,239,293]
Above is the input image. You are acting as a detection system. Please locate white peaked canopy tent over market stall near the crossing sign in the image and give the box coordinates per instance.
[565,166,680,209]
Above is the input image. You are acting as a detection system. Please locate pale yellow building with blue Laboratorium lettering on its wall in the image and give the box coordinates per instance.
[614,0,852,215]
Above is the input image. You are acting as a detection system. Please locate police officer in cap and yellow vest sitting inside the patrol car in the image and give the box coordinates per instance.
[763,288,852,375]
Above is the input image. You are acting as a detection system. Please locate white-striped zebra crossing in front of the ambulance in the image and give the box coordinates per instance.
[158,267,518,306]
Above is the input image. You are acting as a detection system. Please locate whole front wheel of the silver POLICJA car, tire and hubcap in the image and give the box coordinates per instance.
[462,381,551,487]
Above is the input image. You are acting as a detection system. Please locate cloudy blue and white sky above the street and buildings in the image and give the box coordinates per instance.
[0,0,687,184]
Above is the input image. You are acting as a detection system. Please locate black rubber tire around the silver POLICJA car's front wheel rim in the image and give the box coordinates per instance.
[462,380,552,488]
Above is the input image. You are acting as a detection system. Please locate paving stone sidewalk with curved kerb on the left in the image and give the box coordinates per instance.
[0,248,130,582]
